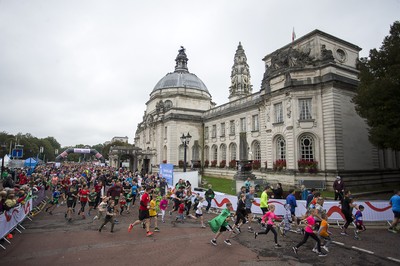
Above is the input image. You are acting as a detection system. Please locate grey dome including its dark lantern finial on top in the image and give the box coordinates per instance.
[153,46,210,94]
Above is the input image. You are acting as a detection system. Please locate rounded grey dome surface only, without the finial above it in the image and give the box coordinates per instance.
[153,72,209,93]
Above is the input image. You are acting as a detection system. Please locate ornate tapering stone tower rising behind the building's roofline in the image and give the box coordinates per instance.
[229,42,253,101]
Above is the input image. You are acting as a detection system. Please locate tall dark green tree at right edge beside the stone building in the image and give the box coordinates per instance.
[353,21,400,150]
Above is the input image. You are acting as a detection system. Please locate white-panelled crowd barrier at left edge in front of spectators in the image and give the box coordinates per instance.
[0,187,46,249]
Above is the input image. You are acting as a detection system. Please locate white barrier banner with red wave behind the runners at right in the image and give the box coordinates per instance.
[200,191,393,222]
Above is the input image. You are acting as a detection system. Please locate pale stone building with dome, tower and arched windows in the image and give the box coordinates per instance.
[135,30,399,188]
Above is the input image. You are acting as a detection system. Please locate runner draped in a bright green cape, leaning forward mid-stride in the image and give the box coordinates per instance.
[208,202,233,246]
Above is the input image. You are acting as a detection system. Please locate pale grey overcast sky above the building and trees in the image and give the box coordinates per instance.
[0,0,400,147]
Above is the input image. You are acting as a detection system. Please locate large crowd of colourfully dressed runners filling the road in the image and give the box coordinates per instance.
[0,163,400,256]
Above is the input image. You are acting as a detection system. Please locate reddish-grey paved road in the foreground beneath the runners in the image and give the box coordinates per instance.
[0,203,400,266]
